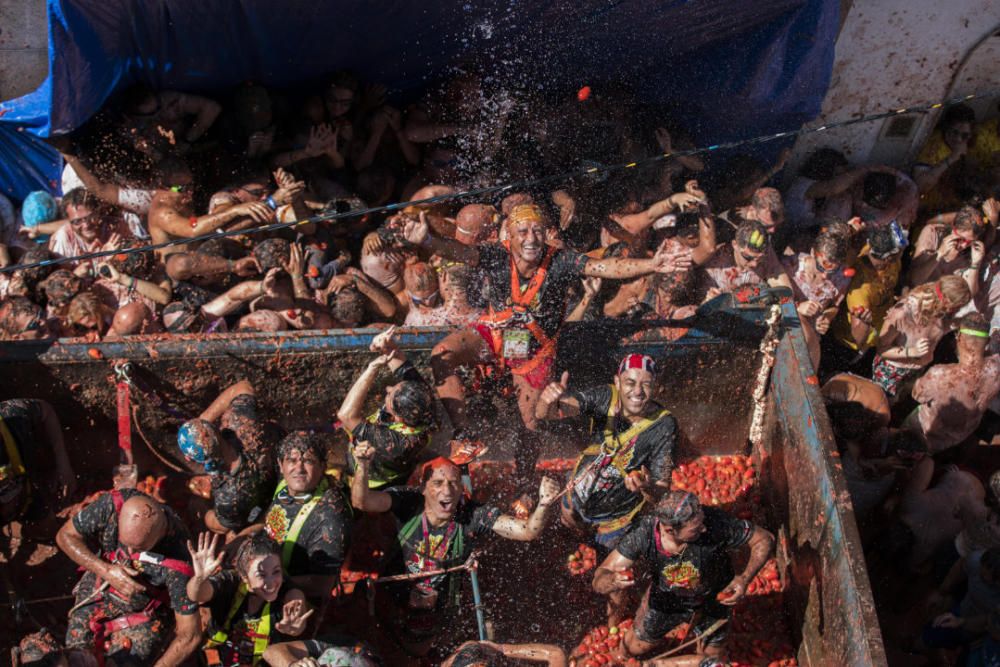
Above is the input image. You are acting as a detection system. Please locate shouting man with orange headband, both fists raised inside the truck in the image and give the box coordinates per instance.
[351,442,559,656]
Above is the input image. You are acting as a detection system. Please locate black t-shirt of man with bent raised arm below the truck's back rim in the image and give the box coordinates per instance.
[347,361,430,489]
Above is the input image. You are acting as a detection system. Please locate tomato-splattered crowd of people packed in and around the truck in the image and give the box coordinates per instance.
[0,72,1000,667]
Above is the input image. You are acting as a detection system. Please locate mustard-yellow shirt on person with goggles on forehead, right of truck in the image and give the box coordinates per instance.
[831,246,900,352]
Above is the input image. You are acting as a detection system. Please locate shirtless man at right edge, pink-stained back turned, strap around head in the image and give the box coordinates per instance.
[903,313,1000,453]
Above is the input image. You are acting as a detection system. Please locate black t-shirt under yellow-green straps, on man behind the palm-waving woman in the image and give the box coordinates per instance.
[265,482,352,580]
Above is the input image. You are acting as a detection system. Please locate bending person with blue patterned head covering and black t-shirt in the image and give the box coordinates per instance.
[177,380,277,534]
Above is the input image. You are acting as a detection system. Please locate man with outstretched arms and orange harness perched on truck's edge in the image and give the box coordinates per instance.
[404,204,691,486]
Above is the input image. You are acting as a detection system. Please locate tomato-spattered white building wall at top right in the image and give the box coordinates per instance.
[786,0,1000,178]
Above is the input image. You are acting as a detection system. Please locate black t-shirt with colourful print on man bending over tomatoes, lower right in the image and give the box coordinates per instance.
[616,507,753,613]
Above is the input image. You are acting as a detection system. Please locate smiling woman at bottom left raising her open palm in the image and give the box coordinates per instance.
[187,532,313,667]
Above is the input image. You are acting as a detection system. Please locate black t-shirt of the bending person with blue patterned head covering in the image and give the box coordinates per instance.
[212,394,277,531]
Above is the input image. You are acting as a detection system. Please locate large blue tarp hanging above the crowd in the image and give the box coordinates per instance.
[0,0,840,198]
